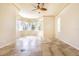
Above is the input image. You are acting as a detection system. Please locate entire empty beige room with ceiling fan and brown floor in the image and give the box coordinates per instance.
[0,3,79,56]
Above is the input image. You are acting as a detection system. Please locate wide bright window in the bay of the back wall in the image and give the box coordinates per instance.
[16,20,41,31]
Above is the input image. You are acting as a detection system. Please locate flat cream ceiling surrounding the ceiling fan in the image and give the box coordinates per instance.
[15,3,68,16]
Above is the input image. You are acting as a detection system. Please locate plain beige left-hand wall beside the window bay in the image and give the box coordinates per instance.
[0,3,16,48]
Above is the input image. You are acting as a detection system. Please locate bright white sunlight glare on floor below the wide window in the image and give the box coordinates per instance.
[16,36,41,55]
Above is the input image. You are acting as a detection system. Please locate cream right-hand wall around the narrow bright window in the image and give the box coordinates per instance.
[55,4,79,49]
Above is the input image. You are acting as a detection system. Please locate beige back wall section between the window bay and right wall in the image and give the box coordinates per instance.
[43,16,55,43]
